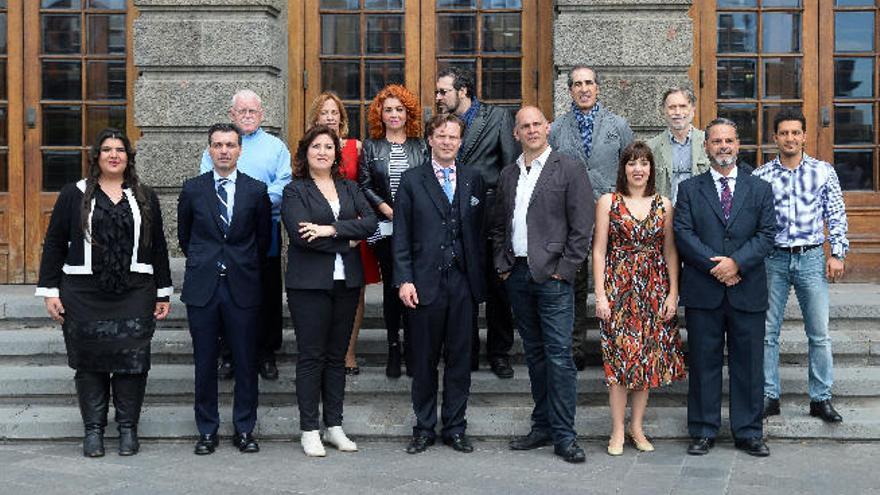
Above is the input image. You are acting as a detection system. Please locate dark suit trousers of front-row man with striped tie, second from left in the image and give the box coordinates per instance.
[186,277,260,434]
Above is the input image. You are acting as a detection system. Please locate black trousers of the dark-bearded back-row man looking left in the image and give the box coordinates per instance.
[471,191,513,367]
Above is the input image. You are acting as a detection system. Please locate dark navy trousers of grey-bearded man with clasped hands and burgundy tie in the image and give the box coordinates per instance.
[685,296,766,438]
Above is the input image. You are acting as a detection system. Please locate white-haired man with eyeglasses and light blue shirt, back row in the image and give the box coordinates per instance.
[199,89,290,380]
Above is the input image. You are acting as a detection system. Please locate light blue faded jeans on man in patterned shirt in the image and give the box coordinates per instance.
[764,247,834,401]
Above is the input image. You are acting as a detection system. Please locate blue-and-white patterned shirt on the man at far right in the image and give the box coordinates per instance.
[753,153,849,257]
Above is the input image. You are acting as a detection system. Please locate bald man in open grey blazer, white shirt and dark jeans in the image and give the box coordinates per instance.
[490,107,595,462]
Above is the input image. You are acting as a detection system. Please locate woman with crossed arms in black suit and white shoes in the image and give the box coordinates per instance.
[281,125,376,457]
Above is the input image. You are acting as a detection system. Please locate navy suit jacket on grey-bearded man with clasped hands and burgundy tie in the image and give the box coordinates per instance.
[673,168,776,312]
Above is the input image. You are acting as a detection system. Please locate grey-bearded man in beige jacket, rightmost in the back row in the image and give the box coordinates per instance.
[648,86,709,204]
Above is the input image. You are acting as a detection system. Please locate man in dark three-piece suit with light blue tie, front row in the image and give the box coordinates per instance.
[393,114,485,454]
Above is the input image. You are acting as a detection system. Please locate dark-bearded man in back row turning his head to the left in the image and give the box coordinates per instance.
[434,67,519,378]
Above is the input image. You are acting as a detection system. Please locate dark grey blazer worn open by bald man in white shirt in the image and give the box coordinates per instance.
[489,151,596,283]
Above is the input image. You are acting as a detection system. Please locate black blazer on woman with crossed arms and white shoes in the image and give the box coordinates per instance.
[281,178,376,289]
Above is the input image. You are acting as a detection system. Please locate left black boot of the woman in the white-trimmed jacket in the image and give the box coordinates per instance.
[73,370,110,457]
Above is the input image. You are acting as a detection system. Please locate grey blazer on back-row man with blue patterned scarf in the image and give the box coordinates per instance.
[550,105,633,201]
